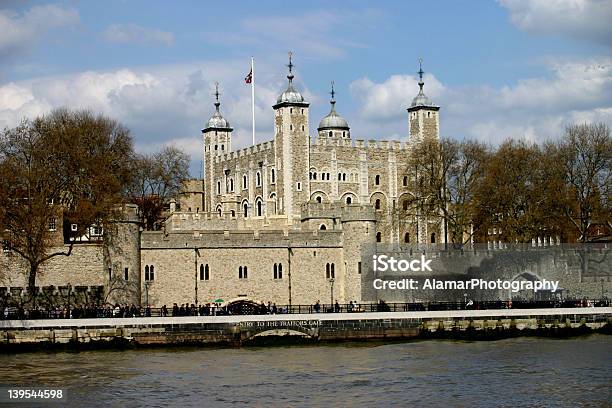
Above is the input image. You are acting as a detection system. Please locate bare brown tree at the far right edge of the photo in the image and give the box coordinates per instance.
[557,123,612,242]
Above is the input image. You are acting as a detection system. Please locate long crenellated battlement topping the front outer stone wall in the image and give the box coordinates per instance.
[142,230,343,250]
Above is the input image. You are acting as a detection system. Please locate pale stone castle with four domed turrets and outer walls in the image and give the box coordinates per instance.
[0,59,609,307]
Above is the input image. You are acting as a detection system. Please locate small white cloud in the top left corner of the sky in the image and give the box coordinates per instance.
[0,4,79,57]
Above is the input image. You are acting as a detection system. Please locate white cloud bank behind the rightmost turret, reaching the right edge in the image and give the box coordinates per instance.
[350,58,612,144]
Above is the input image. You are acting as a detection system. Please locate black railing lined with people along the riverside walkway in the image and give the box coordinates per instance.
[0,299,610,320]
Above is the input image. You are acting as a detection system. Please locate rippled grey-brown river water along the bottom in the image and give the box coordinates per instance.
[0,335,612,407]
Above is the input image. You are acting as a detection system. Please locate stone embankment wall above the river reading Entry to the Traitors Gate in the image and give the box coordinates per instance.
[0,307,612,352]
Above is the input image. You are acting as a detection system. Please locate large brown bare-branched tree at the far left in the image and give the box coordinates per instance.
[0,109,133,292]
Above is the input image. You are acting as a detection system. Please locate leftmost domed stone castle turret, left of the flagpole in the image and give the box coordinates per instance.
[202,83,234,211]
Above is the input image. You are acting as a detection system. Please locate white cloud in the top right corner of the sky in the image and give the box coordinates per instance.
[498,0,612,46]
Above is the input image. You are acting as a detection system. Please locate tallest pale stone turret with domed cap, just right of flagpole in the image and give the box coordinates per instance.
[273,53,310,220]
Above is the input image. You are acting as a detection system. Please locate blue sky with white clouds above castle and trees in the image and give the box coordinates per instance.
[0,0,612,177]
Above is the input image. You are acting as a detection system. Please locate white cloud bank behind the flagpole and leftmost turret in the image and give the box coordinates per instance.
[0,61,294,175]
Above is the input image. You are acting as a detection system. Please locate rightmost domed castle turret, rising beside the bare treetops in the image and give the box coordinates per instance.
[408,59,440,141]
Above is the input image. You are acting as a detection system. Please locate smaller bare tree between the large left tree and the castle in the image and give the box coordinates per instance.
[130,146,189,230]
